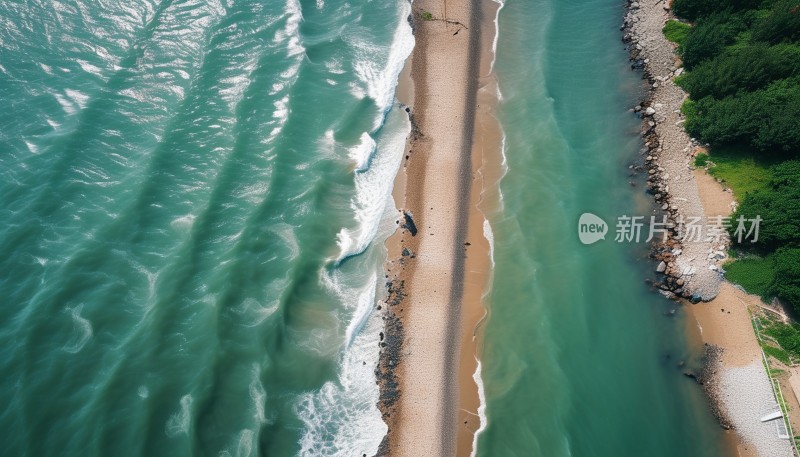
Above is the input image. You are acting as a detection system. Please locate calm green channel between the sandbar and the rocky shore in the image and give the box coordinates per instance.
[478,0,723,457]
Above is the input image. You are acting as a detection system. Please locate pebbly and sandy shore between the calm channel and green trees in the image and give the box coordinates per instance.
[621,0,793,457]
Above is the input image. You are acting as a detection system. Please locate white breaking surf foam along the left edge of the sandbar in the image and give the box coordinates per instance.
[295,2,414,457]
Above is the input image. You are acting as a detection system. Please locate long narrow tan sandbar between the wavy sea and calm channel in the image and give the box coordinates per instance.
[379,0,500,456]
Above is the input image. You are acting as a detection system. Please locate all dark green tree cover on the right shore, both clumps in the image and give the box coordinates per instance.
[676,0,800,314]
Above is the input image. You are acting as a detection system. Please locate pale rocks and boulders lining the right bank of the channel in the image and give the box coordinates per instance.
[620,0,734,430]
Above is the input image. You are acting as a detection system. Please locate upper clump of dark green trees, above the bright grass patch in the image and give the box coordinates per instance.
[674,0,800,157]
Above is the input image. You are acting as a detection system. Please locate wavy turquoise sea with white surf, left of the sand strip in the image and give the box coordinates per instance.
[0,0,413,456]
